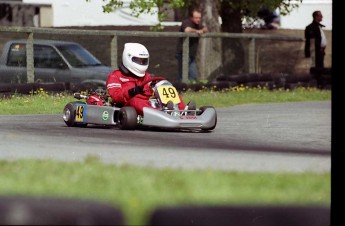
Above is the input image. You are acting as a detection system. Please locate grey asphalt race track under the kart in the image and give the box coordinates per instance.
[0,101,331,173]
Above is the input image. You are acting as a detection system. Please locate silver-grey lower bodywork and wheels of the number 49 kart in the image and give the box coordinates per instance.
[63,101,217,130]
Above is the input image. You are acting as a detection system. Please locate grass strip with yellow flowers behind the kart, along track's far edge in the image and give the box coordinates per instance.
[0,86,331,115]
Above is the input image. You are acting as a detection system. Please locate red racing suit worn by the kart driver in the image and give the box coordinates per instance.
[106,70,185,116]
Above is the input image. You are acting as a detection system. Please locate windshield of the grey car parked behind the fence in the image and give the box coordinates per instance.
[57,44,101,67]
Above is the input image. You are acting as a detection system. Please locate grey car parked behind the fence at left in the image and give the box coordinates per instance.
[0,39,113,92]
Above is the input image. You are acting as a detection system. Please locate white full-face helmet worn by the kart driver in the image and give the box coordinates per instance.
[122,43,149,77]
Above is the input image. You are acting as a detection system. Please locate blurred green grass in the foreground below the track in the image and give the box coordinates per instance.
[0,157,330,225]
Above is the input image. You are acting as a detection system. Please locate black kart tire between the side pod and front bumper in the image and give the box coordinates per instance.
[119,106,138,130]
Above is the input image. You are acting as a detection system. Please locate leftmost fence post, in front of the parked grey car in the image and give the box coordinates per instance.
[26,32,35,83]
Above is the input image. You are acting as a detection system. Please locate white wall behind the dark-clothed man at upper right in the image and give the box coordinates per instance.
[280,0,332,30]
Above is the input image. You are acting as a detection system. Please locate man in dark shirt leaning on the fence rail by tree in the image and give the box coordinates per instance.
[176,9,208,81]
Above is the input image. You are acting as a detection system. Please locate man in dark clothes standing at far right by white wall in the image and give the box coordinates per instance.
[304,10,327,71]
